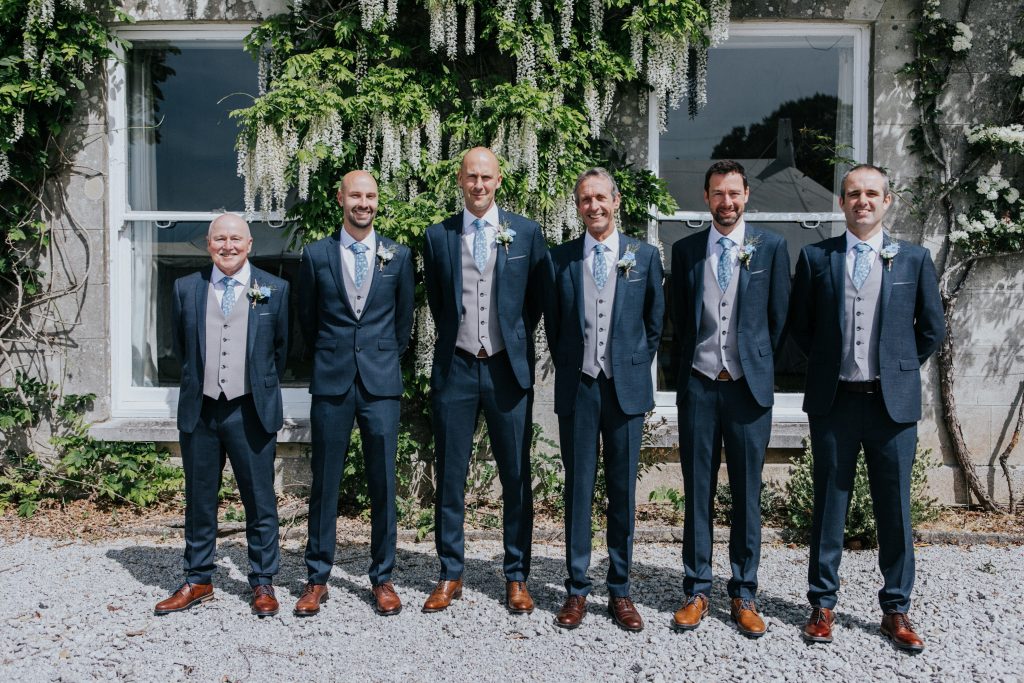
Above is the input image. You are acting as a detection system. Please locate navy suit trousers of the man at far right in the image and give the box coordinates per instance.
[807,389,918,612]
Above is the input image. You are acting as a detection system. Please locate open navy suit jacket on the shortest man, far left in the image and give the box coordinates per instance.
[172,265,288,433]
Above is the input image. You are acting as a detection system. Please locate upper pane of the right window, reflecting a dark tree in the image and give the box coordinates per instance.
[658,36,853,212]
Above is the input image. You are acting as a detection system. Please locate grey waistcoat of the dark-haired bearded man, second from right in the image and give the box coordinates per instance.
[693,256,744,380]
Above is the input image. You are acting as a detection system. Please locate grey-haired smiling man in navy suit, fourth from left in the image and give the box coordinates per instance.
[545,168,665,631]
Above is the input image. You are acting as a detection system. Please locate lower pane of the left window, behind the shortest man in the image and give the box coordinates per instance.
[129,221,310,386]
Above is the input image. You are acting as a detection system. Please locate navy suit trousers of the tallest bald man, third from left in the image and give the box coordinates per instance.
[431,351,534,581]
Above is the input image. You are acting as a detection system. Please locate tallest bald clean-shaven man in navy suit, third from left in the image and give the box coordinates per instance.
[423,147,551,613]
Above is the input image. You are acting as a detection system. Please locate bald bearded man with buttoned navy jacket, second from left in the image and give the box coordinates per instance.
[295,171,415,616]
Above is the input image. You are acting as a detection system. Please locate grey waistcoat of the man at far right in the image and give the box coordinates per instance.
[839,255,884,382]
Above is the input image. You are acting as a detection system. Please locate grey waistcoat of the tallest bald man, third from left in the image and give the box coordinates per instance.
[455,238,505,355]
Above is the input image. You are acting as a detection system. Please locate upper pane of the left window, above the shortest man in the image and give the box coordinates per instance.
[128,42,257,211]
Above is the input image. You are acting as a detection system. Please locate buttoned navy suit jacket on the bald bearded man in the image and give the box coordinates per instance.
[298,230,415,396]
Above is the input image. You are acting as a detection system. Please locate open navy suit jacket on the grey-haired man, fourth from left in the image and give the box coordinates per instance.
[545,232,665,415]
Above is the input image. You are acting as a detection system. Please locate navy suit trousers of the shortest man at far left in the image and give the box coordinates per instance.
[180,394,281,586]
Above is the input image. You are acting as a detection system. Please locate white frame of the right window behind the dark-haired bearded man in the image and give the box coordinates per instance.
[647,22,871,423]
